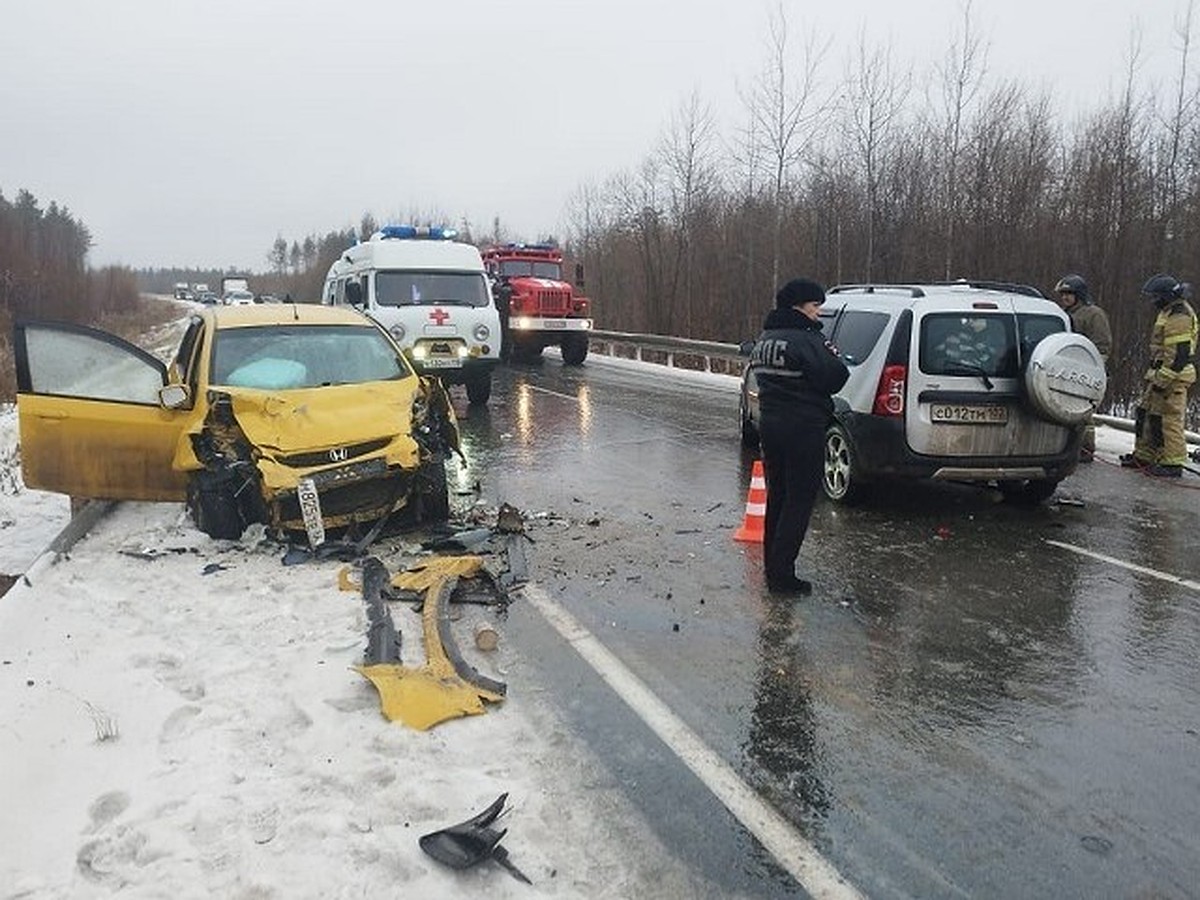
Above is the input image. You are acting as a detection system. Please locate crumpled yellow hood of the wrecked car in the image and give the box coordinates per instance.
[227,378,419,454]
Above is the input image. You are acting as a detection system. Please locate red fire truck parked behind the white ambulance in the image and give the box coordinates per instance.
[482,244,592,366]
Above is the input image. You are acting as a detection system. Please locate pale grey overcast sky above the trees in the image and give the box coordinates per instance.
[0,0,1200,271]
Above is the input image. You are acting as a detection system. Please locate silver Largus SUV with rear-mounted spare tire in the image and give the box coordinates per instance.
[740,281,1105,503]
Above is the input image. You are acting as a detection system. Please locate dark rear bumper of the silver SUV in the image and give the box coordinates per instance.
[836,410,1084,481]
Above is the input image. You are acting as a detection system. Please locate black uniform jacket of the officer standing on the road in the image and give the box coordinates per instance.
[750,308,850,427]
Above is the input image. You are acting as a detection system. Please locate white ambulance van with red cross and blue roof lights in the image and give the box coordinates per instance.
[322,226,500,403]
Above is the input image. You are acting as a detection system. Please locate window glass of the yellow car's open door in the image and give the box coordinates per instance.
[25,326,166,406]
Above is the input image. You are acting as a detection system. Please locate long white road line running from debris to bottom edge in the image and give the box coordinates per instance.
[522,584,863,900]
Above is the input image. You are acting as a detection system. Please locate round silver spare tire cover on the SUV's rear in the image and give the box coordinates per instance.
[1025,331,1108,425]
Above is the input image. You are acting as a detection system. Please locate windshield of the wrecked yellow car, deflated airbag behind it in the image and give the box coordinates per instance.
[210,325,412,390]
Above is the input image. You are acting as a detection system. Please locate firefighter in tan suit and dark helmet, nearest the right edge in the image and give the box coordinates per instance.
[1121,275,1196,478]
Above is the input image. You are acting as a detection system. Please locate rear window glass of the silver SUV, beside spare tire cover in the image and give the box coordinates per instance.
[920,312,1066,378]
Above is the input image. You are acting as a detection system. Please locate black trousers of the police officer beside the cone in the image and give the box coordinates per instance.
[758,416,824,582]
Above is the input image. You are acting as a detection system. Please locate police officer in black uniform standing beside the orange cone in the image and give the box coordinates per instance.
[750,278,850,594]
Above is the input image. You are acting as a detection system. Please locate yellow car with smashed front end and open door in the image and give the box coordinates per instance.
[14,304,458,547]
